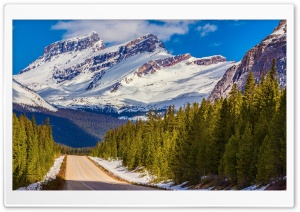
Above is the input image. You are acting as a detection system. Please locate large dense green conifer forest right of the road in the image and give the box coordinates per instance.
[91,60,286,189]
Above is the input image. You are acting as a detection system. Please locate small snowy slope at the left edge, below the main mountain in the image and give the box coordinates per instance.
[12,80,57,112]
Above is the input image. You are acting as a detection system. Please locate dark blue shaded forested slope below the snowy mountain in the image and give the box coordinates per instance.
[14,107,126,148]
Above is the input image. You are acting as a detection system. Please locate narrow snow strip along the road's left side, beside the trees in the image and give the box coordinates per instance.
[17,155,65,190]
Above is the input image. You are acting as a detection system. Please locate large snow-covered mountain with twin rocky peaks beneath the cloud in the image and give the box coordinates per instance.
[13,32,235,113]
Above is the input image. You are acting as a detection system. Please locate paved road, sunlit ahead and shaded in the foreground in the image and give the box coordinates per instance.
[64,155,155,190]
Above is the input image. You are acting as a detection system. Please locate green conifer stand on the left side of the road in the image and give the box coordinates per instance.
[13,113,61,189]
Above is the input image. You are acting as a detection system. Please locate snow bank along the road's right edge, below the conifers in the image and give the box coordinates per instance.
[89,156,188,190]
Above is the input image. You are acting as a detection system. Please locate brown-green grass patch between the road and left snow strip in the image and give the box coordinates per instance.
[42,156,67,190]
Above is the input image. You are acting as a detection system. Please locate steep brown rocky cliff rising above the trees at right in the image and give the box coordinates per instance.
[208,20,287,101]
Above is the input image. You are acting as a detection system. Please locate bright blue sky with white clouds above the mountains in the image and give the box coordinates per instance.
[13,20,279,74]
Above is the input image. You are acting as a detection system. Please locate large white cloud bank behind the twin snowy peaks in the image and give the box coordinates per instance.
[51,20,194,44]
